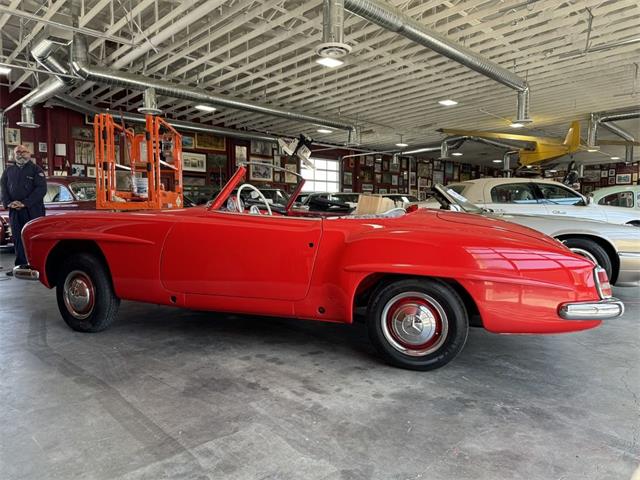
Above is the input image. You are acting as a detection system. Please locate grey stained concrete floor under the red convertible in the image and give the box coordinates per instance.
[0,253,640,480]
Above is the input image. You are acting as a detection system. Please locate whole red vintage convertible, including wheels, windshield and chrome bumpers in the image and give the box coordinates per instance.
[14,164,624,370]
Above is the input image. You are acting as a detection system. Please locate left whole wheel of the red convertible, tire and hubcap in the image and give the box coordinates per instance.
[56,253,120,332]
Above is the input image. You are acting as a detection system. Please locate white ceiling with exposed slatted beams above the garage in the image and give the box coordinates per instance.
[0,0,640,159]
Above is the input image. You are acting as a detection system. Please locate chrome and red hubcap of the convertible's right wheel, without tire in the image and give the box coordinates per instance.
[380,292,448,357]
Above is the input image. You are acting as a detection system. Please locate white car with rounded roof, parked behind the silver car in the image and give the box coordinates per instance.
[447,178,640,226]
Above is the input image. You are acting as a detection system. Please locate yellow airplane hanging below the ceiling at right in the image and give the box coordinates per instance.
[440,120,580,166]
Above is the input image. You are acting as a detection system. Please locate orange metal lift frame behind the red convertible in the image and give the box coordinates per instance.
[93,113,184,210]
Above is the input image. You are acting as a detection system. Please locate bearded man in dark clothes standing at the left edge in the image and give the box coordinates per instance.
[0,145,47,276]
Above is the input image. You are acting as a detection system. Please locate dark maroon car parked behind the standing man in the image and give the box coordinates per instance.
[0,177,96,247]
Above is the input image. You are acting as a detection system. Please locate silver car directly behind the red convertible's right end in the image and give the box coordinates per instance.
[421,184,640,286]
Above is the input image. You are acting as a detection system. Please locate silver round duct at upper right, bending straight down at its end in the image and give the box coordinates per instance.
[344,0,531,123]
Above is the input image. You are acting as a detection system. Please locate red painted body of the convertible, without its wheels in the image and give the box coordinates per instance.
[16,163,622,370]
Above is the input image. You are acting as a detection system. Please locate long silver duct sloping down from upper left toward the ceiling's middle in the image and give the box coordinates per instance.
[71,34,355,132]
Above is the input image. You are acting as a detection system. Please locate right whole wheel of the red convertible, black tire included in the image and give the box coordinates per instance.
[367,279,469,371]
